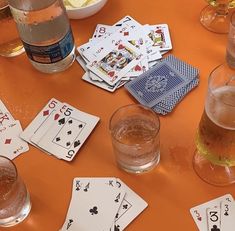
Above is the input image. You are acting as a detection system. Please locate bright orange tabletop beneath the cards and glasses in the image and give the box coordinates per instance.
[0,0,235,231]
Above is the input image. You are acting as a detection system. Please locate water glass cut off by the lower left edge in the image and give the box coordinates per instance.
[0,156,31,227]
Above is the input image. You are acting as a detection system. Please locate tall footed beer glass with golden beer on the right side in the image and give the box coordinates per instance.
[193,64,235,186]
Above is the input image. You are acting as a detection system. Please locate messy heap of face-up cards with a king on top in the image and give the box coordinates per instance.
[77,16,172,92]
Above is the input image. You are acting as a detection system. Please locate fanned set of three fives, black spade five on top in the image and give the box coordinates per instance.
[20,99,99,161]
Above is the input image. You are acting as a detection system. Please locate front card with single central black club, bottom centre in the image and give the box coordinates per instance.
[62,178,125,231]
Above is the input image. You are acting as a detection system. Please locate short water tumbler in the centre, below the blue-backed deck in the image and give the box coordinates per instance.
[109,104,160,173]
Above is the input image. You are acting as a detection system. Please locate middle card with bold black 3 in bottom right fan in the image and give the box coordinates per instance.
[206,206,220,231]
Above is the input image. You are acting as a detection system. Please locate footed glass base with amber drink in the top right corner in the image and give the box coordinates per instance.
[200,0,235,34]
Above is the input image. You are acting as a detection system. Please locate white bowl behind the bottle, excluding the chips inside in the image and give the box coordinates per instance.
[66,0,107,19]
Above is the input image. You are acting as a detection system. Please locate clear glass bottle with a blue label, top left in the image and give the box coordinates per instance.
[9,0,75,73]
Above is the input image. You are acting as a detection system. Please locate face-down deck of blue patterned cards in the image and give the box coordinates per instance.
[125,55,199,115]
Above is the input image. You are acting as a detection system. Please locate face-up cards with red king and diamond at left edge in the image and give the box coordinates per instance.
[0,100,29,160]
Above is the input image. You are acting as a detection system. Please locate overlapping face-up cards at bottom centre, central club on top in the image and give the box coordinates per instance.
[61,177,148,231]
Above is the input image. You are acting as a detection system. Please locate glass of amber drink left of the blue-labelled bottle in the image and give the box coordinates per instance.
[0,0,24,57]
